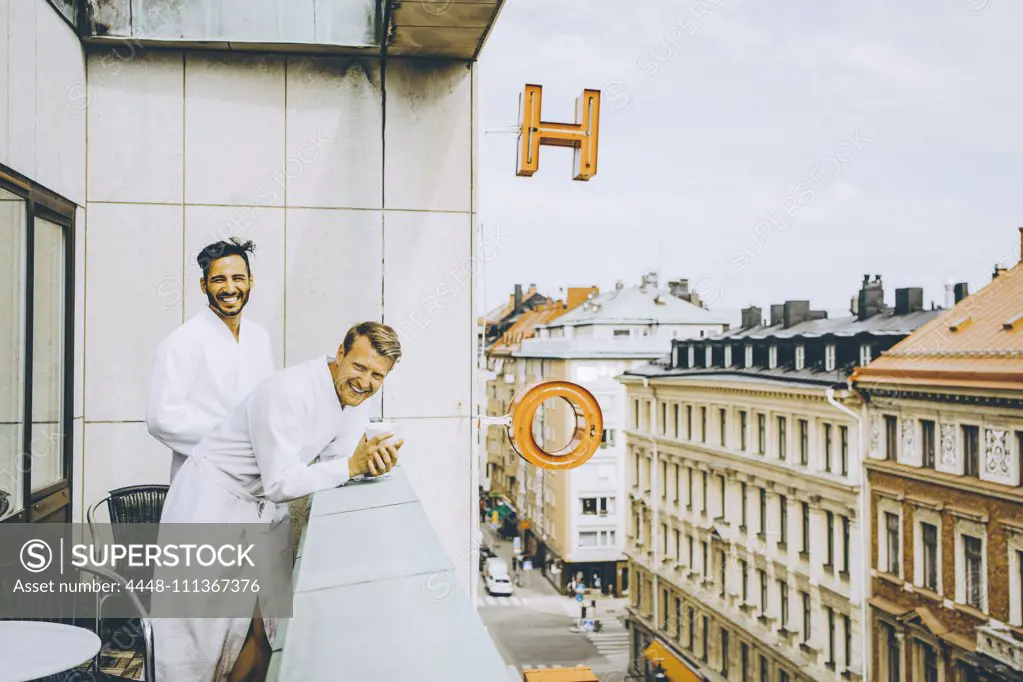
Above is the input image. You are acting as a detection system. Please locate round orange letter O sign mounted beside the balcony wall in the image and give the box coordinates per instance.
[508,381,604,469]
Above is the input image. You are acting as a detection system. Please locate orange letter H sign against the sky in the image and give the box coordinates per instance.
[517,85,601,180]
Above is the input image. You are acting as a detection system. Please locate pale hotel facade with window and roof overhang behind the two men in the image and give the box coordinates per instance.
[0,0,505,584]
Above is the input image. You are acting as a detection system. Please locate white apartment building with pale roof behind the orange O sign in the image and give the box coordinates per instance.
[499,273,727,593]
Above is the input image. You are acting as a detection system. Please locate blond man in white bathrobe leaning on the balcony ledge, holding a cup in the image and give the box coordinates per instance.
[153,322,404,682]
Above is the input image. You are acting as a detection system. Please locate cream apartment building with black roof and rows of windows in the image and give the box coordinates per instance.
[620,276,940,682]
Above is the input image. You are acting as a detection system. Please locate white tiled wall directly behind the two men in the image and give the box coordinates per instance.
[78,48,476,586]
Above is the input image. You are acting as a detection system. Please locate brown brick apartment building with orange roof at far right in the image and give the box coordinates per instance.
[853,240,1023,682]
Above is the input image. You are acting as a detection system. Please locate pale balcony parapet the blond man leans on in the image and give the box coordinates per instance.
[268,467,507,682]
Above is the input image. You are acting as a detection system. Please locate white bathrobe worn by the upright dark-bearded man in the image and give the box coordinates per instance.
[145,306,273,481]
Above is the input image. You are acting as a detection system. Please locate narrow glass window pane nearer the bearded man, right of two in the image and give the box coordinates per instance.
[32,218,66,490]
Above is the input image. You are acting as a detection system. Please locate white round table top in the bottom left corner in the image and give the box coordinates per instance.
[0,621,100,682]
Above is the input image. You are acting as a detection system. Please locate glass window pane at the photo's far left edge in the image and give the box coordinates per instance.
[0,189,28,518]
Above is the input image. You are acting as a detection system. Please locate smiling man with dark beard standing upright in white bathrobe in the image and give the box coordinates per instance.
[145,238,273,481]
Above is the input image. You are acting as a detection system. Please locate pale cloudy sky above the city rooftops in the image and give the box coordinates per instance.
[478,0,1023,319]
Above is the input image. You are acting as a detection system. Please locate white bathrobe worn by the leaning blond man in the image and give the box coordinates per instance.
[152,357,370,682]
